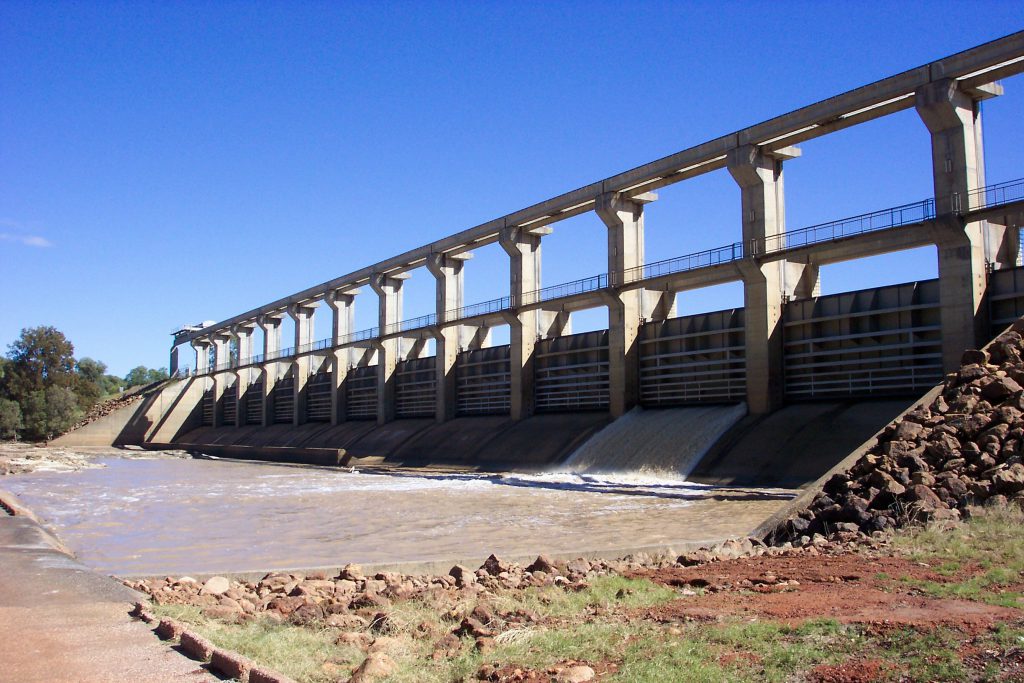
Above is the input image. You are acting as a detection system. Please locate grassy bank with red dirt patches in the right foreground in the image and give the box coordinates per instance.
[142,509,1024,682]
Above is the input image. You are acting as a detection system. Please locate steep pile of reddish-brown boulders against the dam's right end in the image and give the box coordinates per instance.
[769,330,1024,543]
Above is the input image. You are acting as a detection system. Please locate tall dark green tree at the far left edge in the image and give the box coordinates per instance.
[0,327,75,403]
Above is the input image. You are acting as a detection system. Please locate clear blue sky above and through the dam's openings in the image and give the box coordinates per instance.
[0,0,1024,374]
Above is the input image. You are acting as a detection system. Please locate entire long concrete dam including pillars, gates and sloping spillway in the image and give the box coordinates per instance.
[54,32,1024,485]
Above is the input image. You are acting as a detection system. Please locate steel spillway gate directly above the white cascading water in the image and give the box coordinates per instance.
[638,308,746,408]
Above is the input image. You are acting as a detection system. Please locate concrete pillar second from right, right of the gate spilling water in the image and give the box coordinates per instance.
[728,145,806,415]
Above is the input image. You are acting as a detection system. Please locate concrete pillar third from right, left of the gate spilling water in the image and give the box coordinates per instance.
[595,194,656,417]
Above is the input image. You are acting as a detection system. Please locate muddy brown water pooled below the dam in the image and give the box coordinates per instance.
[2,458,795,575]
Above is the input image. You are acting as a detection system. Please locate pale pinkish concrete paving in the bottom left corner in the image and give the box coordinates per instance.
[0,490,216,683]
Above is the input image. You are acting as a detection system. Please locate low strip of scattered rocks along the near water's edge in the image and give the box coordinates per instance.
[125,533,880,638]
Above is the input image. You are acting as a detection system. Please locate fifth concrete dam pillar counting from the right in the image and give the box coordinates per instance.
[427,254,469,422]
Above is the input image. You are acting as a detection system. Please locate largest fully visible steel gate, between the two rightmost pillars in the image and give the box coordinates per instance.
[782,280,942,400]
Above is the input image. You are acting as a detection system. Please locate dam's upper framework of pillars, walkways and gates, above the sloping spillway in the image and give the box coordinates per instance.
[171,32,1024,426]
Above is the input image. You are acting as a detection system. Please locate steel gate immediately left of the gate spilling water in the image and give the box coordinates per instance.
[534,330,608,413]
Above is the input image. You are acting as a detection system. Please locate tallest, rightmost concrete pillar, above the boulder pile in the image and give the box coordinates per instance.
[914,79,995,372]
